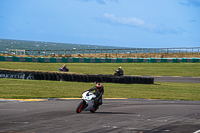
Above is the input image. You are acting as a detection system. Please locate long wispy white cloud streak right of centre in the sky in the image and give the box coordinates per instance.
[103,13,187,34]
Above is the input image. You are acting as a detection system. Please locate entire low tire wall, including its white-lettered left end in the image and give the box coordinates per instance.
[0,70,154,84]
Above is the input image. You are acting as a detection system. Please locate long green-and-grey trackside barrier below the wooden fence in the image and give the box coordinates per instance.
[0,56,200,63]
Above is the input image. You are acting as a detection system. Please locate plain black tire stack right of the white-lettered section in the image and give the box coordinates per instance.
[34,72,154,84]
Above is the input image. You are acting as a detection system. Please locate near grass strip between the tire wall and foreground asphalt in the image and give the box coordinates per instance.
[0,78,200,100]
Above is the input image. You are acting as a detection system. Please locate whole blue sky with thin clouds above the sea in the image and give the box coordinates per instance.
[0,0,200,48]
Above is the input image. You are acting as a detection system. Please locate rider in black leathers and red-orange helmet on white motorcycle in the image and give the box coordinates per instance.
[87,83,104,106]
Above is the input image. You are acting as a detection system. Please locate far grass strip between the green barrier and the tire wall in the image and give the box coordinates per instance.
[0,62,200,77]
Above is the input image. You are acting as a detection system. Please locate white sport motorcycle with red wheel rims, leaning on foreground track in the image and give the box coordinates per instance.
[76,91,98,113]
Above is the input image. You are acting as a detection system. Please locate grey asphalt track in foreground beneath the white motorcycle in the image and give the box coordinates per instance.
[0,99,200,133]
